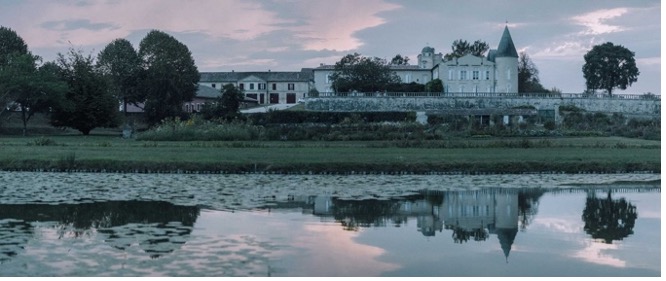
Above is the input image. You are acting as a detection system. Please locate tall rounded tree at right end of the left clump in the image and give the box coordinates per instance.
[139,30,200,124]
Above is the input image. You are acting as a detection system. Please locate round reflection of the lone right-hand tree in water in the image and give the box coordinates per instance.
[582,191,638,244]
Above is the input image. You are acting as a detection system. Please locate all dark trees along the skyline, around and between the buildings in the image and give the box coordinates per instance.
[0,26,639,135]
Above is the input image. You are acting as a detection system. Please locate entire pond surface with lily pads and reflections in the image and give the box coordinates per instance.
[0,172,661,276]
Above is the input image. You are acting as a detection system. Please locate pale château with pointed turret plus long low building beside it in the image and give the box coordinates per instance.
[184,24,518,112]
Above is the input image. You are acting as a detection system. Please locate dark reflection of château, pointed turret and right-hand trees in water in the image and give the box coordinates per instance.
[264,188,637,259]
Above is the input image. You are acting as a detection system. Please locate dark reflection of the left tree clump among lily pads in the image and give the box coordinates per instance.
[0,201,199,262]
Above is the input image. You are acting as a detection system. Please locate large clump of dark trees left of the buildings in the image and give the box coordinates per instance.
[0,27,200,135]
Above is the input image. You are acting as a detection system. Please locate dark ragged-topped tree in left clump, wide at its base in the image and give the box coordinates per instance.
[51,49,118,135]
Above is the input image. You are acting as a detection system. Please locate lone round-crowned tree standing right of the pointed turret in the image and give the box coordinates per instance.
[583,42,640,96]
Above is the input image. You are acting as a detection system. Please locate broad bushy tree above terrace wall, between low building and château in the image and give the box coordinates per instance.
[331,53,400,92]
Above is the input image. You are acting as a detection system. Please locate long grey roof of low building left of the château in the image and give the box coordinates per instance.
[199,68,314,82]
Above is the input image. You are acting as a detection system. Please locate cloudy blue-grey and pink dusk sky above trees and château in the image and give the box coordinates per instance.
[0,0,662,94]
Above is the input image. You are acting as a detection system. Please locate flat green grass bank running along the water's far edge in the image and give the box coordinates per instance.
[0,136,661,174]
